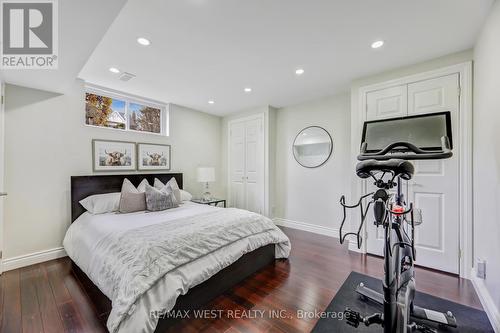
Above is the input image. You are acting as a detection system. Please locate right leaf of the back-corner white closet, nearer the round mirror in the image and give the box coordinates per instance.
[245,118,264,214]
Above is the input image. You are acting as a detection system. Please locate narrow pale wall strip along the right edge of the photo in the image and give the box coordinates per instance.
[473,1,500,329]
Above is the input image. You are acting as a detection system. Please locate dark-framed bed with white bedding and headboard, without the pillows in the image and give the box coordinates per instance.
[63,173,290,332]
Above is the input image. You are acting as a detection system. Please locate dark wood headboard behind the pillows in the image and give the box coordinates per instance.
[71,173,183,222]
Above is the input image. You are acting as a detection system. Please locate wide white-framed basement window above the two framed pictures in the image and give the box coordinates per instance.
[85,89,168,136]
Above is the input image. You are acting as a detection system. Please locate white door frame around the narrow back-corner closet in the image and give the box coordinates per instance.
[226,112,269,216]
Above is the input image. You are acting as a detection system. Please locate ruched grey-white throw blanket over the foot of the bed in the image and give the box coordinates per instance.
[85,208,290,332]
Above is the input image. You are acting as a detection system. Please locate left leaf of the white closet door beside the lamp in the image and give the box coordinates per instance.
[229,122,246,209]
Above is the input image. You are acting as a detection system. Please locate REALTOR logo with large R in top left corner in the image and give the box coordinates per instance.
[0,0,58,69]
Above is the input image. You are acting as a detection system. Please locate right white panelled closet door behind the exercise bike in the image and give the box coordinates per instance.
[408,74,460,273]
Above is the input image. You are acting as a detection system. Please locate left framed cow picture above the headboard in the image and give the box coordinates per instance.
[92,139,137,171]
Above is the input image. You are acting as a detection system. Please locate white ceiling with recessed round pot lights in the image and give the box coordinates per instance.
[0,0,494,115]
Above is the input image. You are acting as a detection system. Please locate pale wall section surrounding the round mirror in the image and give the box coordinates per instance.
[275,93,354,232]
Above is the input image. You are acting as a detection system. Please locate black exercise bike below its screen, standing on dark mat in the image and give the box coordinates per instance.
[340,136,457,333]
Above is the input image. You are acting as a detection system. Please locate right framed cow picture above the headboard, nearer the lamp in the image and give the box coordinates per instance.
[137,143,170,170]
